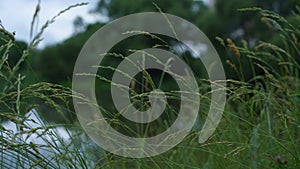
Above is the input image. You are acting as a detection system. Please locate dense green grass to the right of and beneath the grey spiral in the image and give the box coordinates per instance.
[99,8,300,168]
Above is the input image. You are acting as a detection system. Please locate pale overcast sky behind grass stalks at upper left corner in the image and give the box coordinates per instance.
[0,0,101,47]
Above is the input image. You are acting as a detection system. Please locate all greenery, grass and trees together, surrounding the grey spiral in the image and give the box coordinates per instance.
[0,0,300,169]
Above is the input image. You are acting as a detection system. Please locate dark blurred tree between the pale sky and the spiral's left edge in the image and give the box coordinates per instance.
[31,23,102,86]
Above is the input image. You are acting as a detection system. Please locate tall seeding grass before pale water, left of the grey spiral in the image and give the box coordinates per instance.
[0,3,101,168]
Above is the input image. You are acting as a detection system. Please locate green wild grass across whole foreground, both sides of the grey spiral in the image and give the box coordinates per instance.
[0,4,300,169]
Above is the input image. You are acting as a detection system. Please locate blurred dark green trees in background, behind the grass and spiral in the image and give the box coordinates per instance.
[35,0,300,82]
